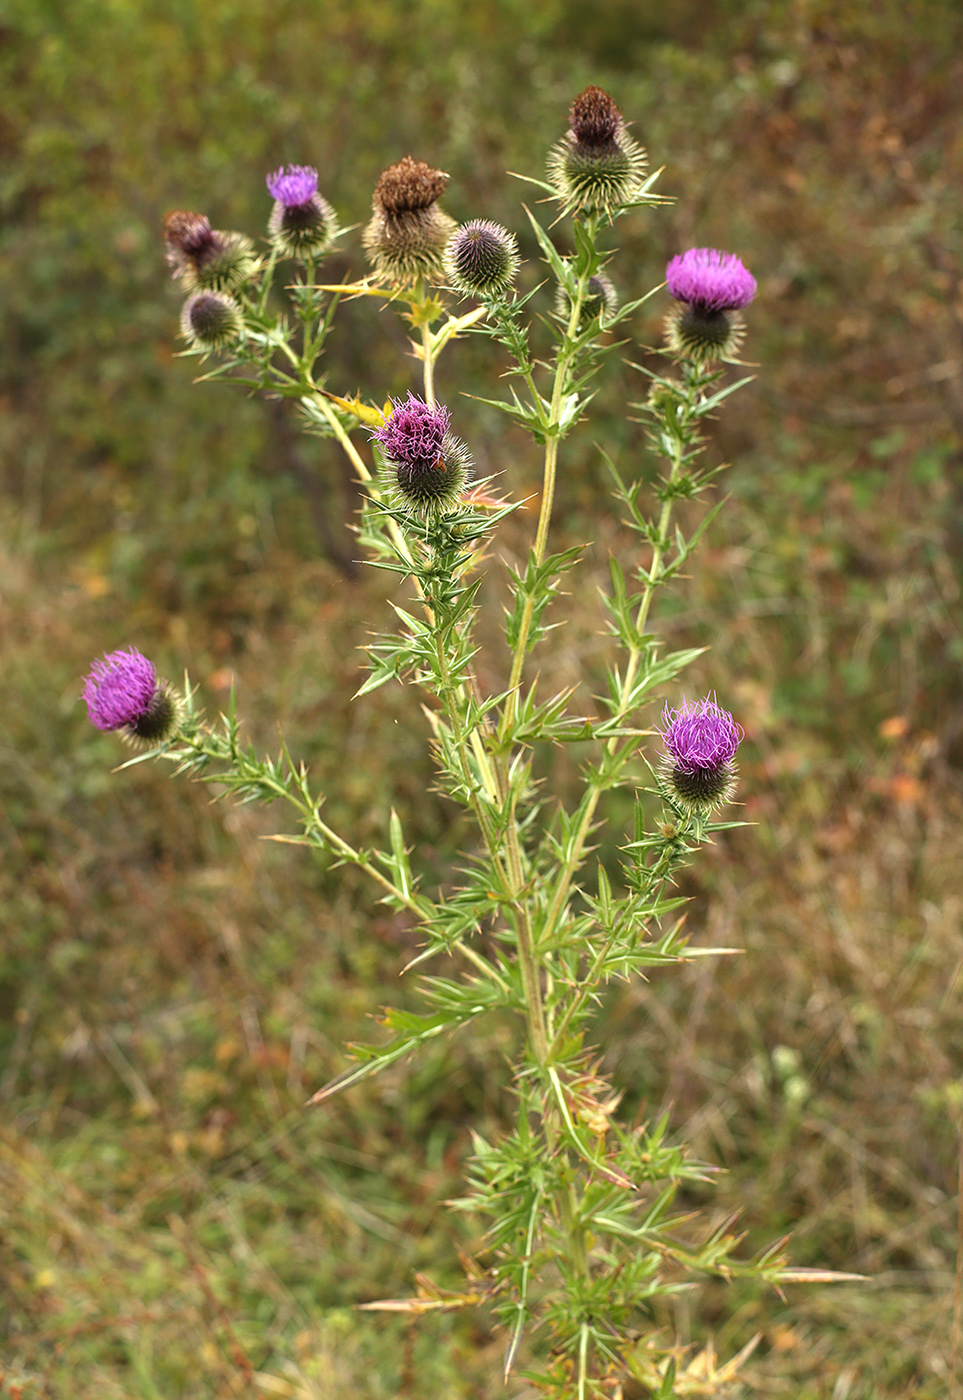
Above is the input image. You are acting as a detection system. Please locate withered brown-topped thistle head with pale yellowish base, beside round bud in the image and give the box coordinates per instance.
[361,155,456,286]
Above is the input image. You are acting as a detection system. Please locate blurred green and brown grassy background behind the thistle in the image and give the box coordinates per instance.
[0,0,963,1400]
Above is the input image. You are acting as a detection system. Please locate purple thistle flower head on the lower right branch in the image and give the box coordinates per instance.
[659,696,745,812]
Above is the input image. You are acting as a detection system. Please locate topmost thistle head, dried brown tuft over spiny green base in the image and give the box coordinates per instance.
[549,87,645,217]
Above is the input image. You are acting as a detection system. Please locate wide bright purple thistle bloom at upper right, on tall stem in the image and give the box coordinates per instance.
[665,248,756,364]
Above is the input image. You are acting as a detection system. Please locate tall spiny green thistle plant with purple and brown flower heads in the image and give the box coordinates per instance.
[85,88,851,1400]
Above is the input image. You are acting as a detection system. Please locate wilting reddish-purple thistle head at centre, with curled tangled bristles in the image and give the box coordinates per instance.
[371,393,472,515]
